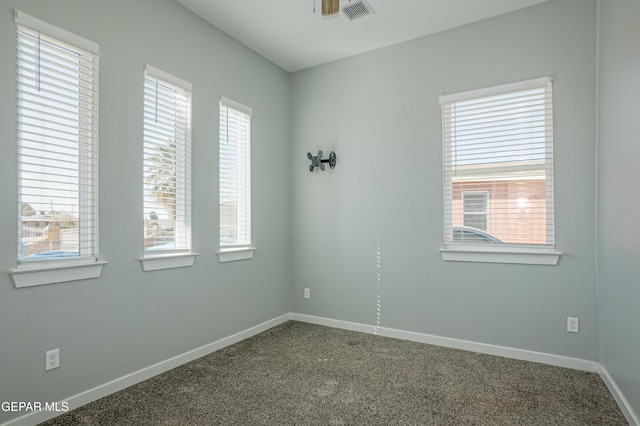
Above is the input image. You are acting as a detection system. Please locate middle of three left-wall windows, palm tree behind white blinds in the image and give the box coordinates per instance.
[143,65,192,254]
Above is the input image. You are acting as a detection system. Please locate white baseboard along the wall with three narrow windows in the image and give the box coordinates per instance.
[2,314,291,426]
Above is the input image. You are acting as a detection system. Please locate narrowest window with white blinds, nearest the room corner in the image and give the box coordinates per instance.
[219,98,252,250]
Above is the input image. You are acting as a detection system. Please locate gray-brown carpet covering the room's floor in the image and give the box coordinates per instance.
[43,322,627,426]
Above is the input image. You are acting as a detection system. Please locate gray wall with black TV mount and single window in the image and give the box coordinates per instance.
[292,0,598,360]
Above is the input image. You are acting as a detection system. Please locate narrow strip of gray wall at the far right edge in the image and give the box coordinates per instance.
[598,0,640,415]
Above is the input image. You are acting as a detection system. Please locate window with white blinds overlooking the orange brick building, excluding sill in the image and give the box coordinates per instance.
[440,77,554,249]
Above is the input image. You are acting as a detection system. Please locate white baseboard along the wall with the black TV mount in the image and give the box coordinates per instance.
[291,313,600,373]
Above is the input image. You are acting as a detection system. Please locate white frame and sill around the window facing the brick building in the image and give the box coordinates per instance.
[440,77,561,265]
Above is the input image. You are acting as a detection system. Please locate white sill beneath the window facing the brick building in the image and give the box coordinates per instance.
[440,247,562,266]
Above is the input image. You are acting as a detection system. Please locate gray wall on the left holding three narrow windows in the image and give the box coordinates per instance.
[0,0,291,423]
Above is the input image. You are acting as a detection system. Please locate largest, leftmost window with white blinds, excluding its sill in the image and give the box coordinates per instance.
[15,11,99,264]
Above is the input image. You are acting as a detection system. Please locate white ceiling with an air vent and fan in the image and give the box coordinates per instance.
[176,0,549,72]
